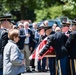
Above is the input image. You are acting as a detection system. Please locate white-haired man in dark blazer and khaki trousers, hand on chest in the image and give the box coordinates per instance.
[23,22,34,72]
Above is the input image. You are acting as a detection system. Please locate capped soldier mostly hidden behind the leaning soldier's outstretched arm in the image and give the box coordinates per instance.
[44,26,56,75]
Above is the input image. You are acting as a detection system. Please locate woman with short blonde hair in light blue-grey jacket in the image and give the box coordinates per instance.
[3,29,25,75]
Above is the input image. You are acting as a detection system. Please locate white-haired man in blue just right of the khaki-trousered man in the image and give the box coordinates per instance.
[30,22,39,71]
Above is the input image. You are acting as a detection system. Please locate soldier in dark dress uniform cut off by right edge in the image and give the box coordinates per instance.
[65,20,76,75]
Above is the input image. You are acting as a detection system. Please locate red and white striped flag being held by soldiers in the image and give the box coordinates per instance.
[29,37,54,60]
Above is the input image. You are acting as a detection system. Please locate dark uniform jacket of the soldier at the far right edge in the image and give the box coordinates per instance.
[65,31,76,59]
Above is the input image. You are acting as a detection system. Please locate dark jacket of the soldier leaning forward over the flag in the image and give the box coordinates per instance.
[40,32,68,59]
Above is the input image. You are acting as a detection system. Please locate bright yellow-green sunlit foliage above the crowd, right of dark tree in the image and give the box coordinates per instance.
[35,6,62,21]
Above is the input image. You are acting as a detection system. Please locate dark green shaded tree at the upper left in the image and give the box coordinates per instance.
[0,0,39,19]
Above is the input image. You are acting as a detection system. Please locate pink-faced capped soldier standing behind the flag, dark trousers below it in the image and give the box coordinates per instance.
[37,24,47,72]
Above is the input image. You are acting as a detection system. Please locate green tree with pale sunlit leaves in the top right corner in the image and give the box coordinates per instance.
[61,0,76,19]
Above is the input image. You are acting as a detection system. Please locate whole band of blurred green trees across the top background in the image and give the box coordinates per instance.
[0,0,76,22]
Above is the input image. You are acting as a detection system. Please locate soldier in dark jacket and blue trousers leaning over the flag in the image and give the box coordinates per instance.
[40,25,68,75]
